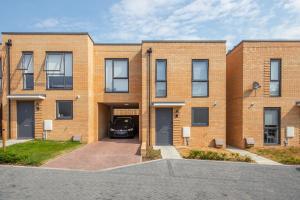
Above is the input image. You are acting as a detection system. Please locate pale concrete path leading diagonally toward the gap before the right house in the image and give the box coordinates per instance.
[227,146,282,165]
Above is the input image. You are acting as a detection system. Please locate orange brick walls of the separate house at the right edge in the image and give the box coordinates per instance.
[227,41,300,148]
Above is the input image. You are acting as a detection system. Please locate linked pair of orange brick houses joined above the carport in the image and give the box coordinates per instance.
[1,33,226,153]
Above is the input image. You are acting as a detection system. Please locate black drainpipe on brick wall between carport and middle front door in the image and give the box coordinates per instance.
[147,48,152,146]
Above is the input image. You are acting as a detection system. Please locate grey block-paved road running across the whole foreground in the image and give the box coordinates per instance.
[0,160,300,200]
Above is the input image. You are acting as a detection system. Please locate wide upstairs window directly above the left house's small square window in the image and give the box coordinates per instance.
[46,52,73,89]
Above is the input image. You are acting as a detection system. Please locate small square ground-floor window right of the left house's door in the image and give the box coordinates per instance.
[56,100,73,119]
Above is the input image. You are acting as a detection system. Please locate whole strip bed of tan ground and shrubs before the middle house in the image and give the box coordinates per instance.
[177,147,253,162]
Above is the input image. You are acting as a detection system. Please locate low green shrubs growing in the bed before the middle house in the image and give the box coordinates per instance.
[185,150,252,162]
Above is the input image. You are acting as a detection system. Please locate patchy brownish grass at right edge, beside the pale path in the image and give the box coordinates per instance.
[249,147,300,165]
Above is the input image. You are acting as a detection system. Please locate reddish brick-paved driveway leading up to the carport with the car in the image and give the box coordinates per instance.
[43,138,141,170]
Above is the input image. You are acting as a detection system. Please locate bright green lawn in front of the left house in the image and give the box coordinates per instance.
[0,140,82,166]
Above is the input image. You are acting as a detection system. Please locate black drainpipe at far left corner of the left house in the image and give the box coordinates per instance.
[2,39,12,149]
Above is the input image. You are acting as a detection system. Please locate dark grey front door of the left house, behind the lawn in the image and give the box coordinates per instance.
[17,101,34,138]
